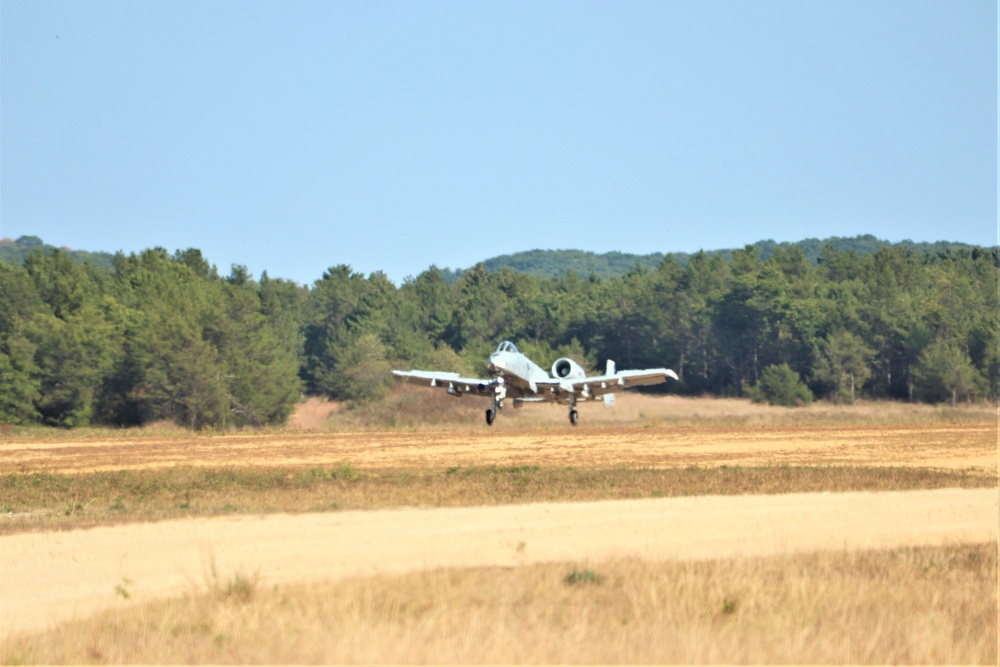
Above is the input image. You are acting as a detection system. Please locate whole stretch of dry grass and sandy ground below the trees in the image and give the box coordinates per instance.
[0,388,998,664]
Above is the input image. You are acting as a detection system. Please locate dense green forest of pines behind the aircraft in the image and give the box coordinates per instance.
[0,244,1000,428]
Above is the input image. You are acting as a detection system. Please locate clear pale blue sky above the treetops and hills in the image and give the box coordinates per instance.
[0,0,998,284]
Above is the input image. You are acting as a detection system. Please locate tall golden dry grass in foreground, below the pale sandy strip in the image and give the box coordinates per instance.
[0,544,998,665]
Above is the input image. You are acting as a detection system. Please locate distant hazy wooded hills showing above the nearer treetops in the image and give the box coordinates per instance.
[0,234,979,283]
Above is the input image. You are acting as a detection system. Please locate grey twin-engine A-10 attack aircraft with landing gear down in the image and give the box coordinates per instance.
[392,340,678,426]
